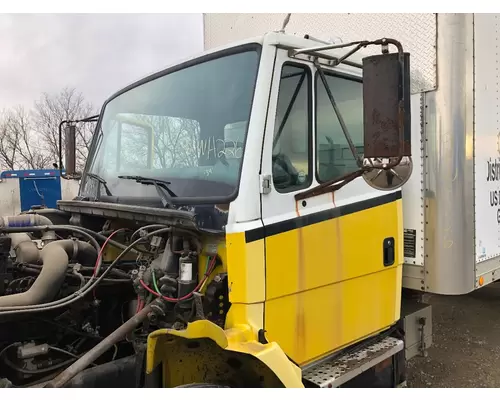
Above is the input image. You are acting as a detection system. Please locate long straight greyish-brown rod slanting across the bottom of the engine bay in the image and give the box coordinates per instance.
[44,300,157,388]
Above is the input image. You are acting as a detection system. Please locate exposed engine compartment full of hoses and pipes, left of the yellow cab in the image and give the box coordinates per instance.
[0,205,230,387]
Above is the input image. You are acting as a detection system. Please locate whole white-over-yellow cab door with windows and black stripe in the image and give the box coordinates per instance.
[261,50,402,365]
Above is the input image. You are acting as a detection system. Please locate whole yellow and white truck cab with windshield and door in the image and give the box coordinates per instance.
[56,32,411,386]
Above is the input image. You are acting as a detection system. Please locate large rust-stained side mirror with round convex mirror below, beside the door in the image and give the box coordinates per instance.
[363,52,412,190]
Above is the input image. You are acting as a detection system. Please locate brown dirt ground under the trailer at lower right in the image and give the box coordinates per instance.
[408,284,500,388]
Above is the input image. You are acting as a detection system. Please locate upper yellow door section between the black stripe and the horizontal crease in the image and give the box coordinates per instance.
[266,194,403,300]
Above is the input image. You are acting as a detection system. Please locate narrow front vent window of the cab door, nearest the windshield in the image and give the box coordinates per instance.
[272,64,312,192]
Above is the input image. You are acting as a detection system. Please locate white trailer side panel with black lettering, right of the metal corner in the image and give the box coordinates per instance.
[474,14,500,287]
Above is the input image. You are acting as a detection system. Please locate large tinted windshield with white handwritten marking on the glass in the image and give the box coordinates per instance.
[84,48,259,202]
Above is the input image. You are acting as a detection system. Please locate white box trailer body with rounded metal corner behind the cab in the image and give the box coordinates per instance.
[204,14,500,295]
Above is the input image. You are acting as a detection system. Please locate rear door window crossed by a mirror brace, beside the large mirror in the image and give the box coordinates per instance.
[316,75,363,182]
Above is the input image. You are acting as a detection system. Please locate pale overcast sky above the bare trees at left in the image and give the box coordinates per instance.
[0,14,203,110]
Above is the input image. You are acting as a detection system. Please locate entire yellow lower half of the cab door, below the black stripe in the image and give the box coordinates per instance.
[264,193,403,364]
